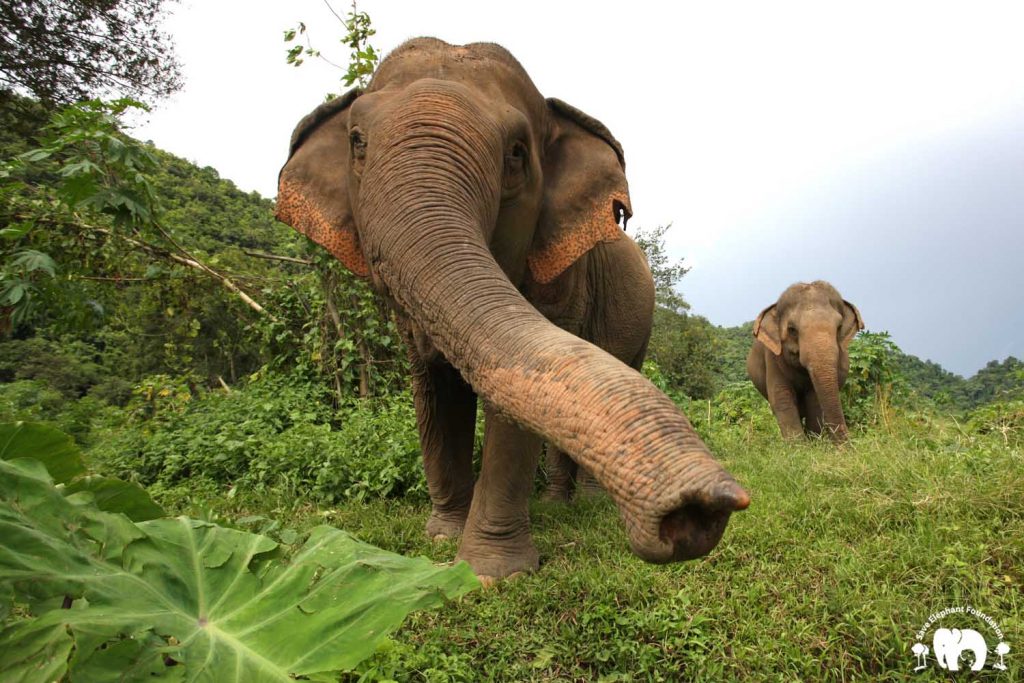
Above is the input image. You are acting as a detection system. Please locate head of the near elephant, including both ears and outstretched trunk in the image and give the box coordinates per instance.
[278,38,750,562]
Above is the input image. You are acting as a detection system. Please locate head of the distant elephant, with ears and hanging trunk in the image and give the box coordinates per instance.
[754,281,864,442]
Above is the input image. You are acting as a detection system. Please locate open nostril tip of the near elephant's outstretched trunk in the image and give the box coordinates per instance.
[630,471,751,564]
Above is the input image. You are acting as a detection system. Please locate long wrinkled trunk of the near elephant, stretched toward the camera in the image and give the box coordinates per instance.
[358,85,750,562]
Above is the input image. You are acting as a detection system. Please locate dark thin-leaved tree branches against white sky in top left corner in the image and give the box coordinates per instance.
[0,0,182,104]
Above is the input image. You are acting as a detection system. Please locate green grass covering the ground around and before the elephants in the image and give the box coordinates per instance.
[125,418,1024,681]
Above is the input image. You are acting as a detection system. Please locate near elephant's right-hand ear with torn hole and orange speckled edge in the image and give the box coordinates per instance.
[526,99,633,284]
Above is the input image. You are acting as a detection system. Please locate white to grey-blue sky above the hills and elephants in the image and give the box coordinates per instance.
[134,0,1024,376]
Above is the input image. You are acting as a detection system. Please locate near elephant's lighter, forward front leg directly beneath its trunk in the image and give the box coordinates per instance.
[459,405,543,579]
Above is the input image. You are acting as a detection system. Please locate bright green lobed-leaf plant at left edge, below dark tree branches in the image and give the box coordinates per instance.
[0,99,157,328]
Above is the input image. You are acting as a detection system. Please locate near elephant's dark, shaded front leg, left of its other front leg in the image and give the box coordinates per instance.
[412,358,476,538]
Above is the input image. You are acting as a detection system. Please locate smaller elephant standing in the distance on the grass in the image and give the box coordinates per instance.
[746,280,864,442]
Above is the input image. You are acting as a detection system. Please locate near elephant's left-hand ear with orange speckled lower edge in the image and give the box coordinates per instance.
[276,88,370,276]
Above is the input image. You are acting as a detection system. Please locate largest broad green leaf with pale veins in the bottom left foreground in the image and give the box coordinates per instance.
[0,460,478,683]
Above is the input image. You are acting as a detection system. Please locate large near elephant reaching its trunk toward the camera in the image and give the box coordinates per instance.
[278,38,750,578]
